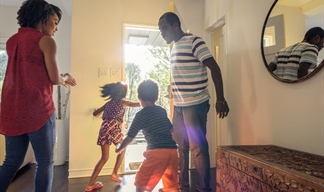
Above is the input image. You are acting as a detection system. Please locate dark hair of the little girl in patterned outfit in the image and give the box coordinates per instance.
[100,82,127,100]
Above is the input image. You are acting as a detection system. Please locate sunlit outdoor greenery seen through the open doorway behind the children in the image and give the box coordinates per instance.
[125,47,170,130]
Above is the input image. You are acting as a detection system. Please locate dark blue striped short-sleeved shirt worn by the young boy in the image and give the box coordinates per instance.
[127,105,177,150]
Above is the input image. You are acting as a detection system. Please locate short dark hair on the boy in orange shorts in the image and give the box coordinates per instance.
[137,79,159,102]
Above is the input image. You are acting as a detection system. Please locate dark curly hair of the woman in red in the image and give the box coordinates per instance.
[17,0,62,28]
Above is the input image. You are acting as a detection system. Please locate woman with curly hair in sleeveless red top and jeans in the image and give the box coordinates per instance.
[0,0,76,192]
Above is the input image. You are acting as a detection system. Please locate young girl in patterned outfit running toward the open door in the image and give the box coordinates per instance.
[85,82,140,191]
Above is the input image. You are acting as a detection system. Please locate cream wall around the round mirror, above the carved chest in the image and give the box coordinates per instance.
[205,0,324,155]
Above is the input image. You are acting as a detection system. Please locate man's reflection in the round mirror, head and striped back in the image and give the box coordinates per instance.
[269,27,324,81]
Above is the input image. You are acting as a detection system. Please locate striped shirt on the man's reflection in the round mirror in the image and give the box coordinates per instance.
[271,42,318,80]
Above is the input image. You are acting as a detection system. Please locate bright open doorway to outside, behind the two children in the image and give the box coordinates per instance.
[123,25,170,174]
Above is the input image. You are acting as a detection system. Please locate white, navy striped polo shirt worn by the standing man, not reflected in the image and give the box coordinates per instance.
[171,35,212,107]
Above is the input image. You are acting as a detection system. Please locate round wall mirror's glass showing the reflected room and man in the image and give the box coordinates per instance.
[261,0,324,83]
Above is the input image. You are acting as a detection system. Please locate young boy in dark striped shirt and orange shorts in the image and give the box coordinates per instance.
[116,79,179,192]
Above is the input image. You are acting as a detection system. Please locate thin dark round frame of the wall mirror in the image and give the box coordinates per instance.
[261,0,324,83]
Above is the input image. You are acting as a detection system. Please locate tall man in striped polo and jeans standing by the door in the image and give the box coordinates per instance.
[158,12,229,192]
